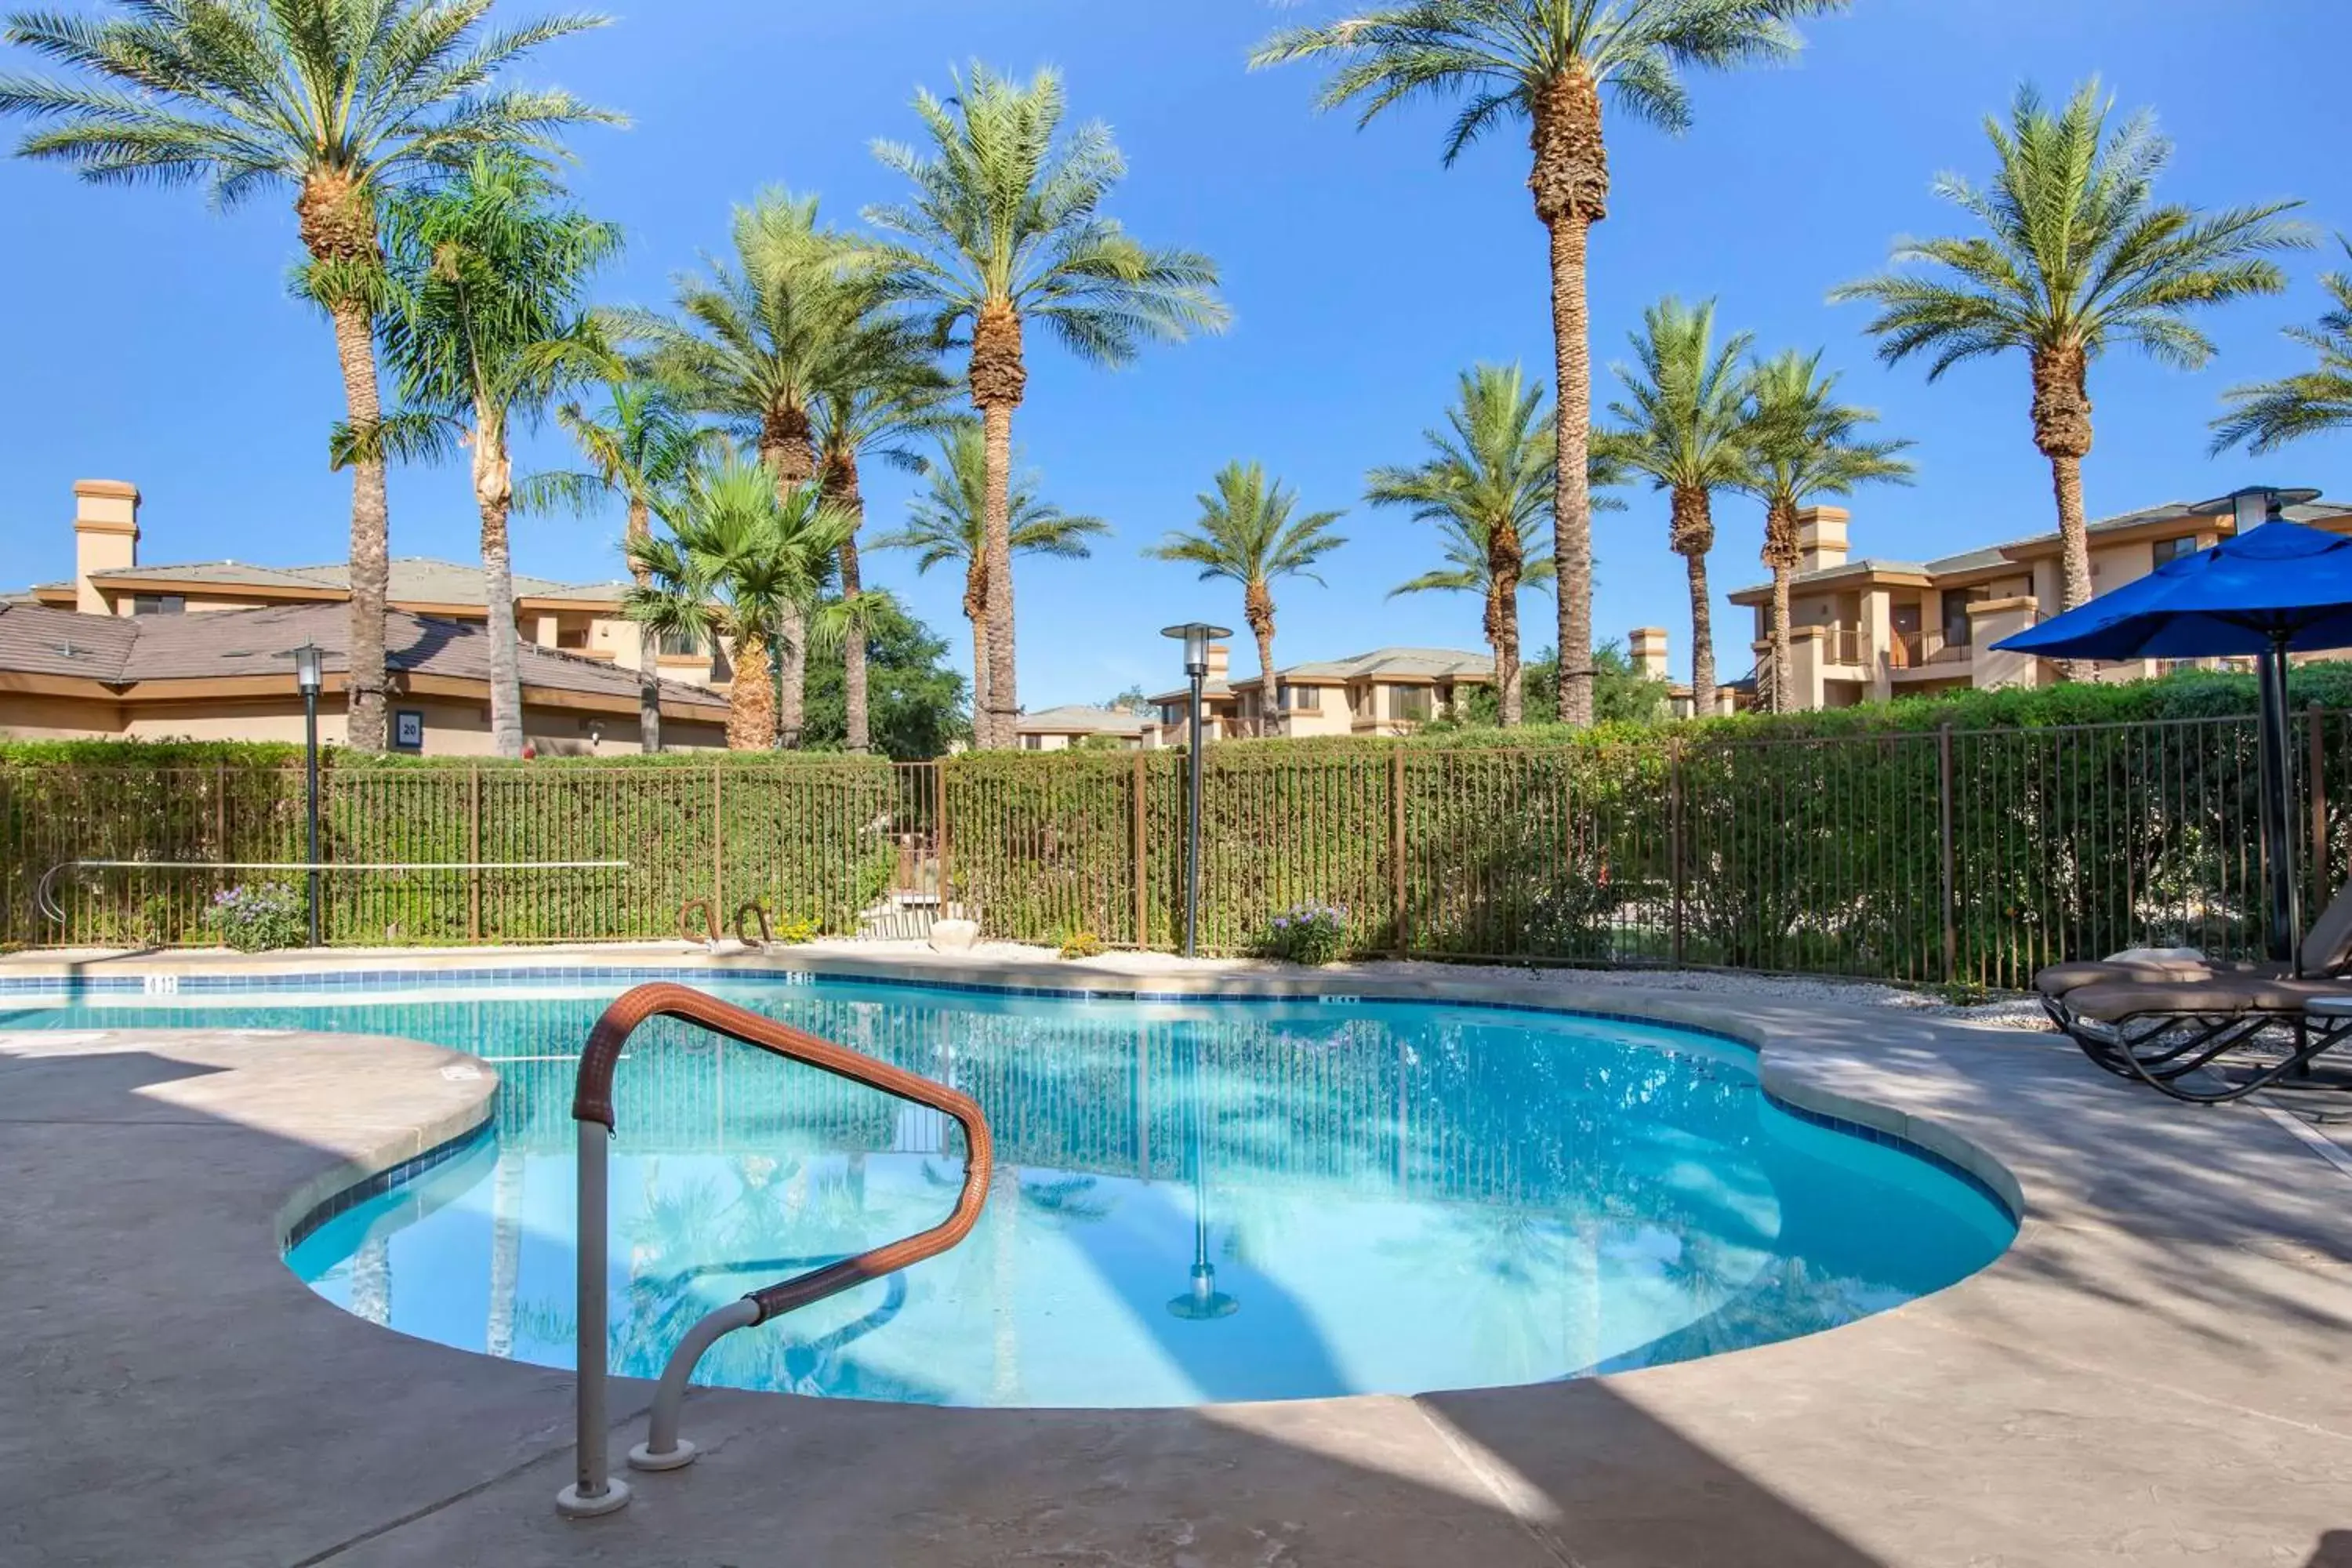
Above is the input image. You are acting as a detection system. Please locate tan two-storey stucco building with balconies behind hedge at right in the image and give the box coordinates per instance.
[1731,503,2352,708]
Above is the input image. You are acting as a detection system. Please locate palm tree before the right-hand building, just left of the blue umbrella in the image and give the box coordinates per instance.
[1830,80,2307,677]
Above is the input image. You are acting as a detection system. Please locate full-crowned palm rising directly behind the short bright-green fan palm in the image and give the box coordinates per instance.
[612,191,906,746]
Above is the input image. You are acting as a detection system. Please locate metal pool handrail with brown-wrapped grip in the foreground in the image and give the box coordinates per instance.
[555,982,995,1519]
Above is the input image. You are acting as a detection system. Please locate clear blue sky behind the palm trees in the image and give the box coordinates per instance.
[0,0,2352,708]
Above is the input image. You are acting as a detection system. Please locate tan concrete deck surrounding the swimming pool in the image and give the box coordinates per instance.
[0,952,2352,1568]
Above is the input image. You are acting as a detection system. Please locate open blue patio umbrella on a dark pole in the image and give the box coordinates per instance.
[1994,487,2324,961]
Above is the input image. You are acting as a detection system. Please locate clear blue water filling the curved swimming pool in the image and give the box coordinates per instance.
[0,980,2016,1406]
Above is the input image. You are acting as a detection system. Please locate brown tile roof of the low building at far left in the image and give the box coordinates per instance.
[0,604,727,717]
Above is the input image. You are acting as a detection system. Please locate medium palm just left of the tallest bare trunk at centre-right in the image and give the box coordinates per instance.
[1367,365,1557,727]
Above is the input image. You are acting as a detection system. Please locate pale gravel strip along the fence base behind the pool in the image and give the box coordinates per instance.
[816,940,2051,1029]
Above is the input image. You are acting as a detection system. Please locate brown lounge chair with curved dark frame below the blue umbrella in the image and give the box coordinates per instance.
[2034,884,2352,1105]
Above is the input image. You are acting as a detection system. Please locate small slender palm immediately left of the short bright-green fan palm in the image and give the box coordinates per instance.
[541,376,715,755]
